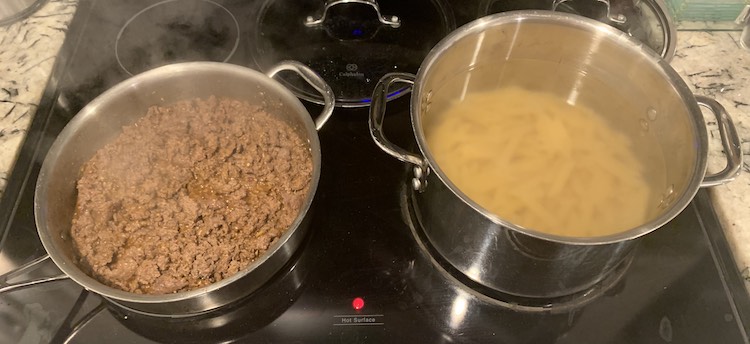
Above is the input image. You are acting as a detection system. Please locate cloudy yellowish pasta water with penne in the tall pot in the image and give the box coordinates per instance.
[425,87,651,237]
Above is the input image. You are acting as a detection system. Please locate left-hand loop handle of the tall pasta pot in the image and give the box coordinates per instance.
[370,73,426,167]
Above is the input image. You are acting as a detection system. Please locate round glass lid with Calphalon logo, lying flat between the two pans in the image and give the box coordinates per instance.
[249,0,456,107]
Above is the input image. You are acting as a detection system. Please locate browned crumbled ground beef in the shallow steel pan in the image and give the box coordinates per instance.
[71,97,313,294]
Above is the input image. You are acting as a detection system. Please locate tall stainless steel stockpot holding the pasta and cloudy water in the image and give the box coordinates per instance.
[370,11,742,298]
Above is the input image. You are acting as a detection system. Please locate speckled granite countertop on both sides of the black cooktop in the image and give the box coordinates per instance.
[0,0,750,290]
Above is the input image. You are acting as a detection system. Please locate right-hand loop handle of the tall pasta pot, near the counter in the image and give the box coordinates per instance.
[695,96,742,187]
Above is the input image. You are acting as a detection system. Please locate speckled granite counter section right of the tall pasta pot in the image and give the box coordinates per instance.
[672,31,750,290]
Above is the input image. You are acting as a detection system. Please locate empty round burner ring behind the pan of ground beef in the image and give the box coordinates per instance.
[115,0,240,75]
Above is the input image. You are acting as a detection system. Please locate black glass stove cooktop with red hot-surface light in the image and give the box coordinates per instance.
[0,0,750,344]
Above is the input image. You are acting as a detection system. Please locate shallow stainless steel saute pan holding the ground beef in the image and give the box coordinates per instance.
[0,61,334,316]
